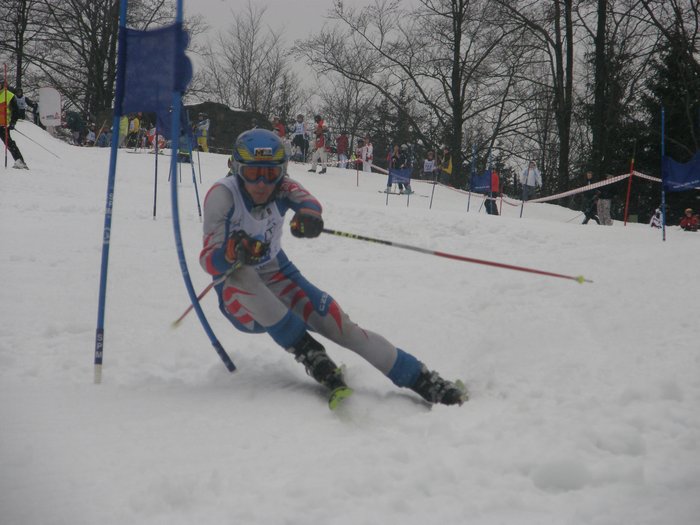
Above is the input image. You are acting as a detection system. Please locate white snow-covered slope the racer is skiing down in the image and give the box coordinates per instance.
[0,122,700,525]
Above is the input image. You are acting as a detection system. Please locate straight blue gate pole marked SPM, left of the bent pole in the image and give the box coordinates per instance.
[94,0,128,384]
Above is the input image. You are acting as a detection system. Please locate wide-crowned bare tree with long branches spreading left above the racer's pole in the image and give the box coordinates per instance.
[295,0,524,185]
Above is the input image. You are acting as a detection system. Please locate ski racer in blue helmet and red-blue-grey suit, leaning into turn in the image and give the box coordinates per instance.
[200,129,466,405]
